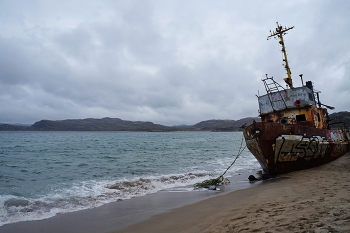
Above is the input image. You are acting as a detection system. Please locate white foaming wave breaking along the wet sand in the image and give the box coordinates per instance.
[0,173,214,226]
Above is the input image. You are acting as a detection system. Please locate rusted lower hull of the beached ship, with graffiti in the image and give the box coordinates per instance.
[243,122,349,175]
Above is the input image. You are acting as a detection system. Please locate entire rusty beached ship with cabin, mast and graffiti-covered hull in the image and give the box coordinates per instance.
[243,23,350,176]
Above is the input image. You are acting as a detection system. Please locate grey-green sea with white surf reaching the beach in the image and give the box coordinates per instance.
[0,131,260,226]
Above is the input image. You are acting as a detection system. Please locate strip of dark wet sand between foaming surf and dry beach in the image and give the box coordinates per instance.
[0,172,260,233]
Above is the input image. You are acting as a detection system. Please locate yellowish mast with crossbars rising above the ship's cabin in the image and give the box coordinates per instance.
[267,22,294,89]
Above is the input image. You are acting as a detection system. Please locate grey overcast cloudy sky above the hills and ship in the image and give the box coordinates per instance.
[0,0,350,125]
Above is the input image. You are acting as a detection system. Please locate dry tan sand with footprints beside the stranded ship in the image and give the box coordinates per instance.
[114,153,350,233]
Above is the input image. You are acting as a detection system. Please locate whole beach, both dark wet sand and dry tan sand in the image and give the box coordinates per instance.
[0,153,350,233]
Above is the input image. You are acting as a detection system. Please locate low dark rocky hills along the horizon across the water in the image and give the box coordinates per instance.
[0,112,350,132]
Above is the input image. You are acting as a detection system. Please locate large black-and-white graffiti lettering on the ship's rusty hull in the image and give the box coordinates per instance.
[274,135,329,164]
